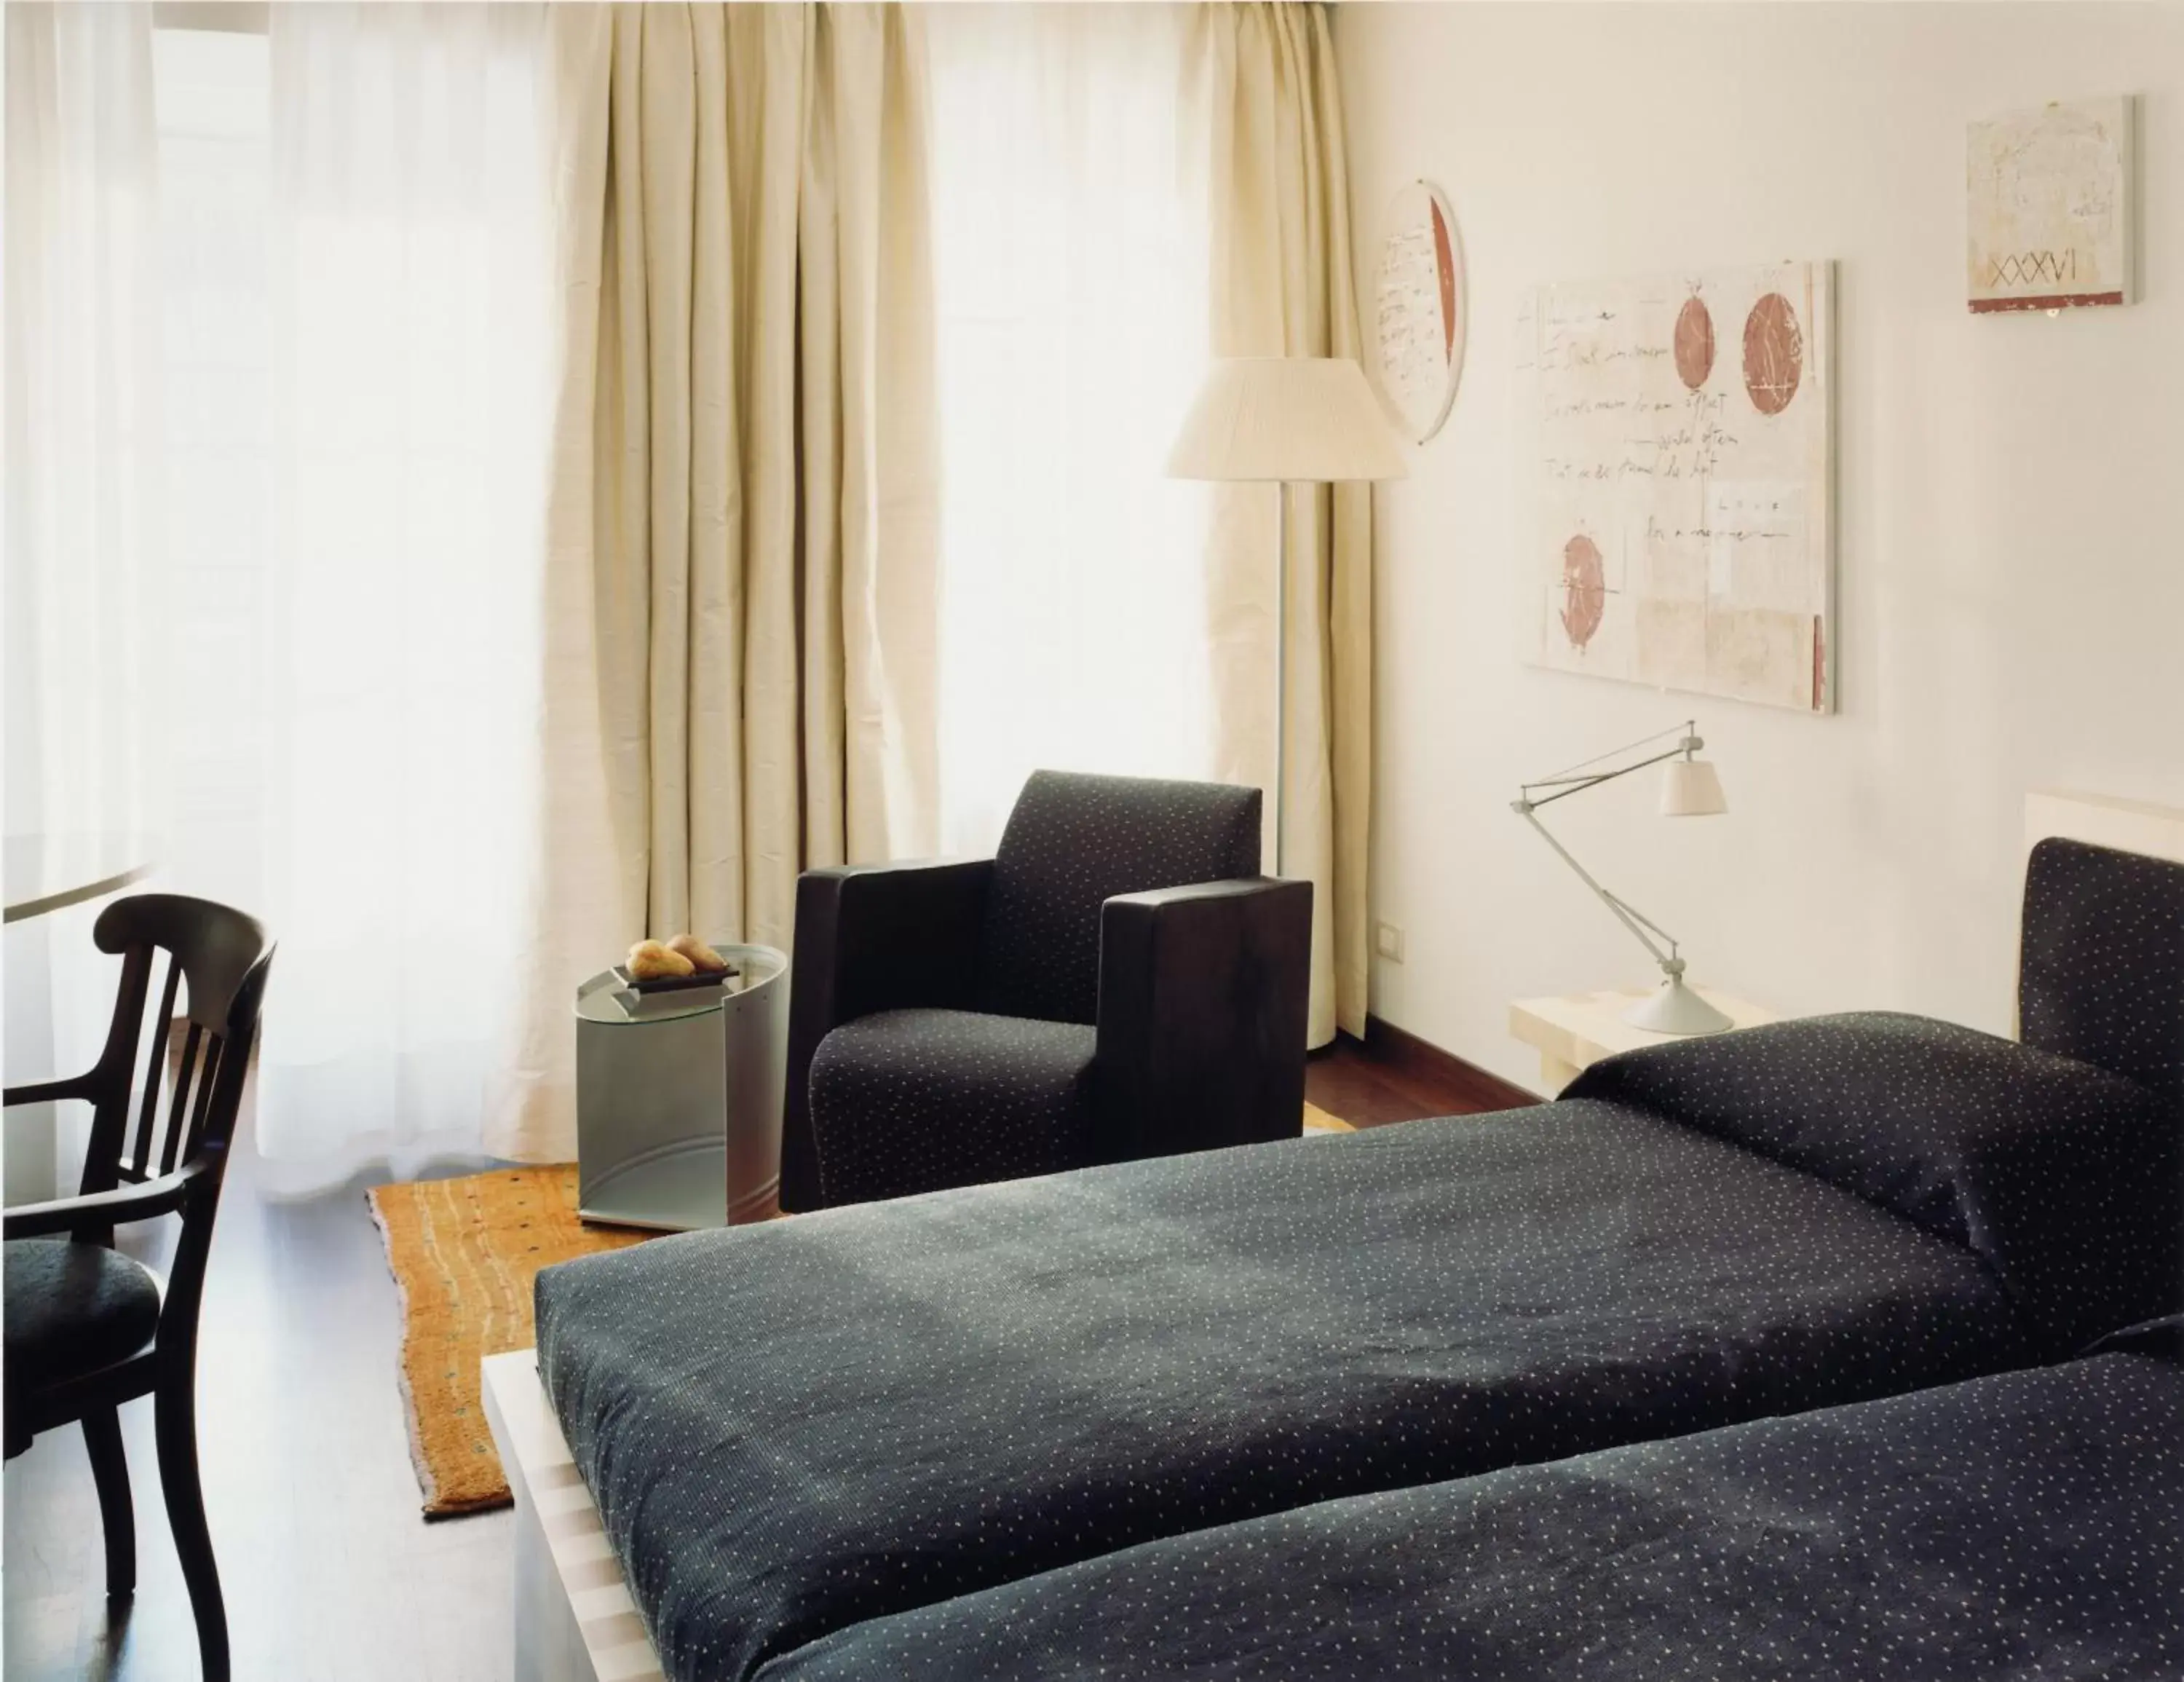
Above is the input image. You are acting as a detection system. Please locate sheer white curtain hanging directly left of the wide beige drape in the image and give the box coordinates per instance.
[241,4,550,1173]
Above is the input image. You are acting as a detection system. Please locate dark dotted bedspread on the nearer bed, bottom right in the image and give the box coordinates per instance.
[764,1354,2184,1682]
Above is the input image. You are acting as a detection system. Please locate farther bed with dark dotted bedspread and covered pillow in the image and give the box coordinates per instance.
[494,808,2184,1678]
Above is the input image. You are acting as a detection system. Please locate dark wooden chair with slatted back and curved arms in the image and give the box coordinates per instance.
[4,893,273,1682]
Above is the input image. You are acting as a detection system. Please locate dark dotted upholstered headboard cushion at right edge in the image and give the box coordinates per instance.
[2018,839,2184,1105]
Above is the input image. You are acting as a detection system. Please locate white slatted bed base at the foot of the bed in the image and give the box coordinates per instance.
[480,1350,666,1682]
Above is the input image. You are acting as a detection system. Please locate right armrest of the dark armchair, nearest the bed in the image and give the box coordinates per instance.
[1092,876,1313,1162]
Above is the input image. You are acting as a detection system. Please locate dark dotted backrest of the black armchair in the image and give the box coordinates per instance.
[978,771,1260,1022]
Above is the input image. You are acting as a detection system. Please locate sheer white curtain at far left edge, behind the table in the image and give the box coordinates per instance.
[0,4,168,1201]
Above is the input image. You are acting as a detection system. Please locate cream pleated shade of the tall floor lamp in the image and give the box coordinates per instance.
[1168,356,1409,483]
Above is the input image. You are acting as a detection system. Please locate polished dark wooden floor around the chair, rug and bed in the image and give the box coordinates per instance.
[0,1040,1487,1682]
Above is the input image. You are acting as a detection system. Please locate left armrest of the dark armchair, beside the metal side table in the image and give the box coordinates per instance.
[782,858,994,1210]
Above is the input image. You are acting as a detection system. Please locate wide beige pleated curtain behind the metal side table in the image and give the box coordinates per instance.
[489,4,939,1160]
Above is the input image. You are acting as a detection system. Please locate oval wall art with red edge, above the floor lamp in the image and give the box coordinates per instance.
[1374,181,1465,443]
